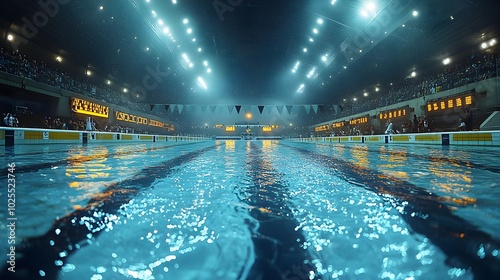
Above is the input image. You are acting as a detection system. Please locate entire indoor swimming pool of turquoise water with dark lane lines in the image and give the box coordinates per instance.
[0,141,500,280]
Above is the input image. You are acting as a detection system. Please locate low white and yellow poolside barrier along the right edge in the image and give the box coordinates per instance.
[293,131,500,146]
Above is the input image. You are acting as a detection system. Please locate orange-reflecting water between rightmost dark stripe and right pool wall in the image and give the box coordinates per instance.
[302,144,500,241]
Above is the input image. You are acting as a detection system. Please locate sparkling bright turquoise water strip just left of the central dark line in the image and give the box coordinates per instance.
[62,142,253,279]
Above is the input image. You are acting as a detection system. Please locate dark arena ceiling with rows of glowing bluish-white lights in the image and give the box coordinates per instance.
[0,0,500,104]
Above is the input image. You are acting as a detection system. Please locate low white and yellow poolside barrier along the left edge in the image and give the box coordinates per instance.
[0,127,209,146]
